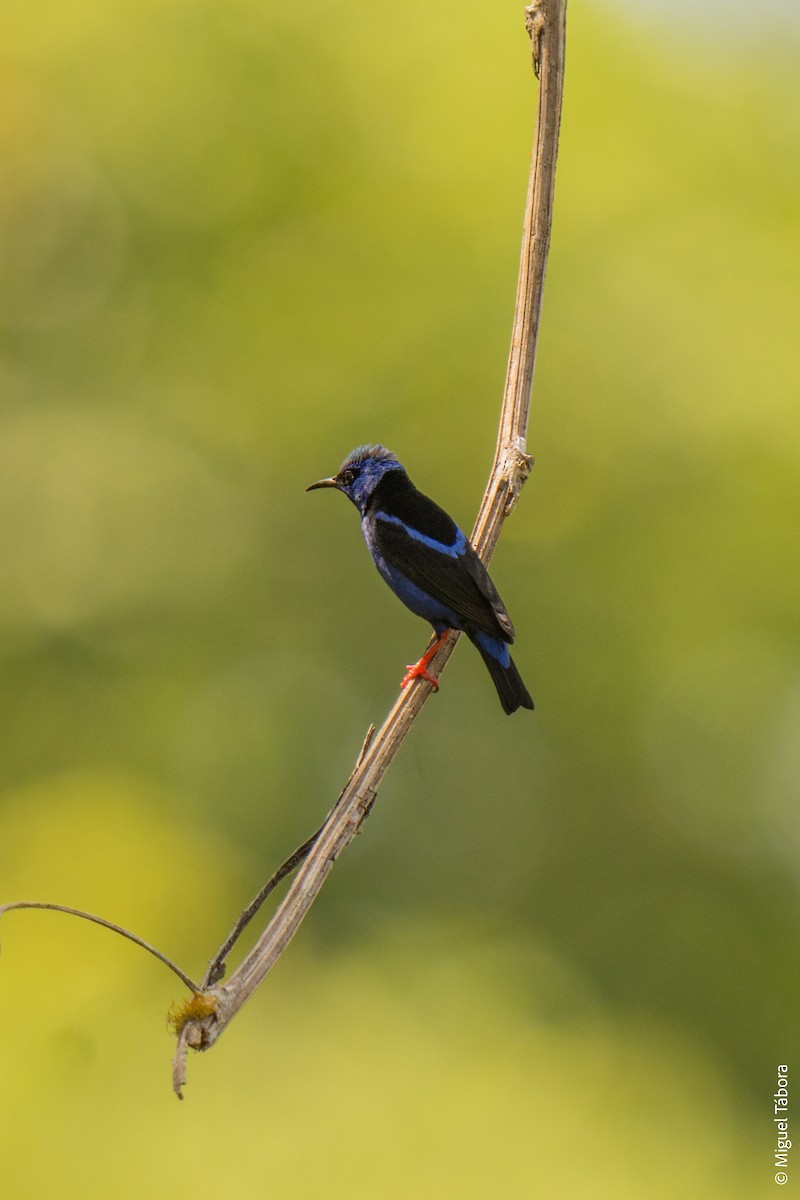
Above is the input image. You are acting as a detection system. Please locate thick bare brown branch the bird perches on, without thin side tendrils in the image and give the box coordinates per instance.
[173,0,566,1096]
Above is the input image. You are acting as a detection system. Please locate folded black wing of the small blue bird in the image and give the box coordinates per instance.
[373,493,515,642]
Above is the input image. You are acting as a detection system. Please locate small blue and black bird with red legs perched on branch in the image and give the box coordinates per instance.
[306,445,534,713]
